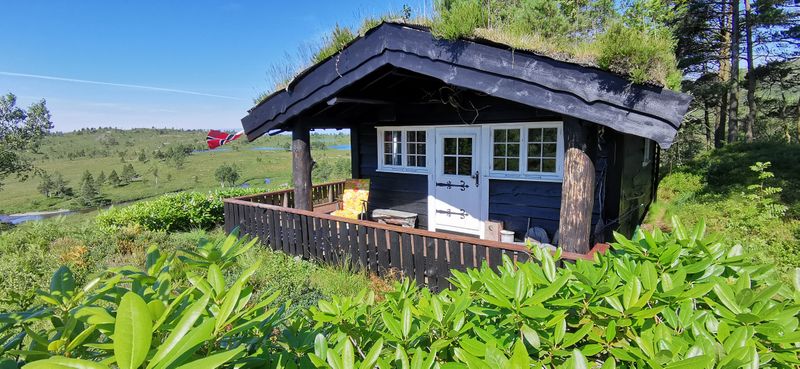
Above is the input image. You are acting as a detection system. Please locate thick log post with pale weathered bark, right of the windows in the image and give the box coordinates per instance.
[558,120,595,254]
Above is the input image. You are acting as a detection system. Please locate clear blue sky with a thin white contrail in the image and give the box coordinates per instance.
[0,0,431,131]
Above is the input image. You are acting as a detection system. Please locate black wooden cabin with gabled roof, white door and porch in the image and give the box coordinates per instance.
[226,23,690,270]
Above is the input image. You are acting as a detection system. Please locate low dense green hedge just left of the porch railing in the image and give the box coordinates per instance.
[97,188,264,232]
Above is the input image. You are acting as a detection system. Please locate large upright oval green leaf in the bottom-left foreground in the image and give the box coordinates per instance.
[113,292,153,369]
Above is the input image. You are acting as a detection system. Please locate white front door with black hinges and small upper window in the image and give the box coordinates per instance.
[430,127,482,236]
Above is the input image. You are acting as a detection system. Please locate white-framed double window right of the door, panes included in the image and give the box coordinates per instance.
[484,122,564,181]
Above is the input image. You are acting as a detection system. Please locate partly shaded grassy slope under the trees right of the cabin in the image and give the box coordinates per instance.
[646,143,800,279]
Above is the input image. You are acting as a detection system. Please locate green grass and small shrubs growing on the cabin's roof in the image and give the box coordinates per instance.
[254,0,682,105]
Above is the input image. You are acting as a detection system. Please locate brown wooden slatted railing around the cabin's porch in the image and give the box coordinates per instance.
[224,182,604,290]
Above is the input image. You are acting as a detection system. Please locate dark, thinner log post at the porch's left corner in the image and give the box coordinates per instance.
[292,123,313,210]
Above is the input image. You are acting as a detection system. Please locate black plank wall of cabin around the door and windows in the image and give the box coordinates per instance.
[340,90,640,241]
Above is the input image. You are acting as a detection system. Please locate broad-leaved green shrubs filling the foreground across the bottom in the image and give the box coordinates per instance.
[0,221,800,368]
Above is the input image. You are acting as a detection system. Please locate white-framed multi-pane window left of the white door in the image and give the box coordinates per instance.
[378,127,430,173]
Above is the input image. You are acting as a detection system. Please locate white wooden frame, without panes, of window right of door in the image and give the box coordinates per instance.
[482,121,564,182]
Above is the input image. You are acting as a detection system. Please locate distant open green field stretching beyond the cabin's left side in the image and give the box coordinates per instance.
[0,129,350,214]
